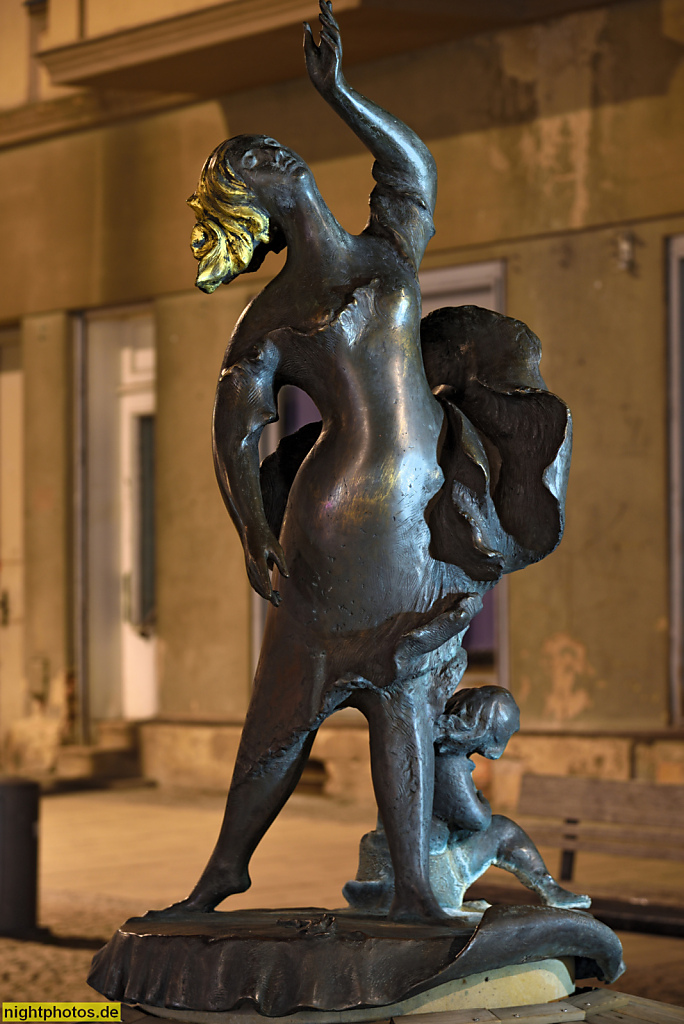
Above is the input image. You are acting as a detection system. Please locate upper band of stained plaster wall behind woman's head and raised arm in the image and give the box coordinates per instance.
[0,0,684,319]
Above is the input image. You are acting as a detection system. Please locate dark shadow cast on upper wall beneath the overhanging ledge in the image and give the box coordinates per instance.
[219,3,684,162]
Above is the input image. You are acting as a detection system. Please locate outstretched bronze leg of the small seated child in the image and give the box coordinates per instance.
[485,814,592,910]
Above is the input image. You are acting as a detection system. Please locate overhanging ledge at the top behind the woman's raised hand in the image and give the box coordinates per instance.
[38,0,621,96]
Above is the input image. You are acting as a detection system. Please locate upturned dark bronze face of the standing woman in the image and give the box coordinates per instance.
[230,135,311,204]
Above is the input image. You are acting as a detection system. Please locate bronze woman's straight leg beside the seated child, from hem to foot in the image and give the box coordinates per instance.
[356,689,453,924]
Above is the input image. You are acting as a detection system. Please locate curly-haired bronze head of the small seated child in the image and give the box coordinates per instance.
[435,686,520,760]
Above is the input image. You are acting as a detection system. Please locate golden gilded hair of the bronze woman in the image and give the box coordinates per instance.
[187,139,271,292]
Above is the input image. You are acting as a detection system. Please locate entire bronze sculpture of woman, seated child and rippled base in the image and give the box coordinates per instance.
[91,2,621,1015]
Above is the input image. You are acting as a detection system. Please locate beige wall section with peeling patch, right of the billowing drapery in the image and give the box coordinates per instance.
[509,219,684,729]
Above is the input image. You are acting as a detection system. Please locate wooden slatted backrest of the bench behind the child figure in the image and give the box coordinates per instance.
[518,775,684,828]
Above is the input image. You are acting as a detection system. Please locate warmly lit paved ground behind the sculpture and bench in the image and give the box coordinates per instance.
[0,790,684,1006]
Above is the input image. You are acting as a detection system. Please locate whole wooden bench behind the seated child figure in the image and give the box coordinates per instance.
[467,775,684,937]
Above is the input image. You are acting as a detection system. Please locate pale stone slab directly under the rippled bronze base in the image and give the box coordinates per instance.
[141,956,574,1024]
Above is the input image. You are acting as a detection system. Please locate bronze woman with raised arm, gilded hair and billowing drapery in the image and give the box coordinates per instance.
[178,2,569,922]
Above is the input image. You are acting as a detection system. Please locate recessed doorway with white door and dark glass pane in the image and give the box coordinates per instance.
[80,306,158,721]
